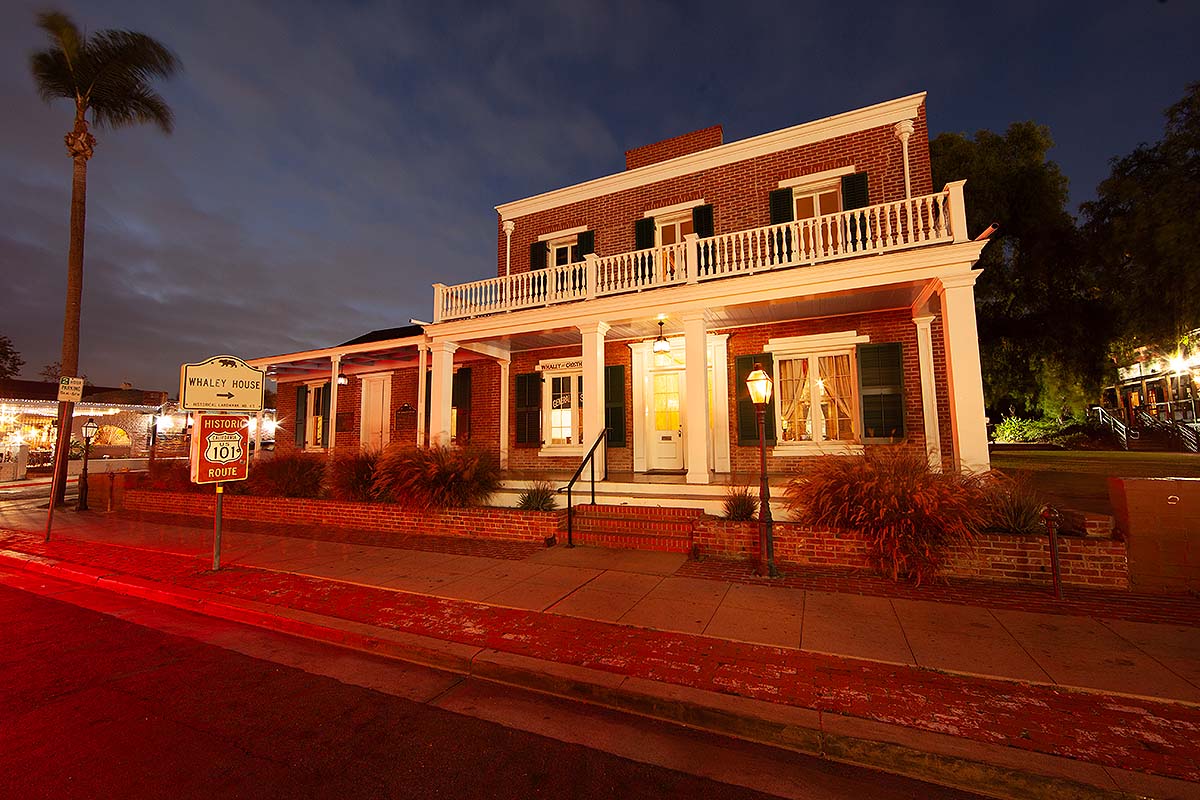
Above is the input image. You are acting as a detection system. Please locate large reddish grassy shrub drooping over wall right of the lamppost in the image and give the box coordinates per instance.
[787,447,988,584]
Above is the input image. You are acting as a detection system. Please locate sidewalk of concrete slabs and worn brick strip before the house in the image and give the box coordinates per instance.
[0,510,1200,796]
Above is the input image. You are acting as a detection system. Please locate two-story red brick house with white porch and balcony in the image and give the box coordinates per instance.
[252,94,989,485]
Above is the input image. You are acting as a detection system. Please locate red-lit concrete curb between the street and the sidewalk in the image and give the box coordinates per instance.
[0,549,1200,800]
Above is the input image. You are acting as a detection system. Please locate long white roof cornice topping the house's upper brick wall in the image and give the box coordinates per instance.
[496,91,925,219]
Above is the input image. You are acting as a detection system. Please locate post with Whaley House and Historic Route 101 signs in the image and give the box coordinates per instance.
[179,355,266,571]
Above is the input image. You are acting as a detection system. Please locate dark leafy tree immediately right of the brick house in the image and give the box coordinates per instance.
[930,122,1109,419]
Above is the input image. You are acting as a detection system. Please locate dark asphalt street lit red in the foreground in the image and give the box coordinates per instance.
[0,572,974,800]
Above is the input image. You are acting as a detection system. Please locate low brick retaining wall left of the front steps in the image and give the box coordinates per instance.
[125,489,566,542]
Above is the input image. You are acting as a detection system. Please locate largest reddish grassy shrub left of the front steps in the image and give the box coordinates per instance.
[372,443,500,509]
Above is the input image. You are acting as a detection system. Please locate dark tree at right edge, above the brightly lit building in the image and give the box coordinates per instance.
[1084,83,1200,351]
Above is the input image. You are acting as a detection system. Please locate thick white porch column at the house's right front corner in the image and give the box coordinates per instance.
[940,277,991,473]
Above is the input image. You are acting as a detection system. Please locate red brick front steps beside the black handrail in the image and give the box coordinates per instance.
[560,504,704,553]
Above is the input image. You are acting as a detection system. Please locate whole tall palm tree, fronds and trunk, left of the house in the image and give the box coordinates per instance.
[29,11,179,520]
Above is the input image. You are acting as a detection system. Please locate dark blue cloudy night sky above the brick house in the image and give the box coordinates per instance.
[0,0,1200,395]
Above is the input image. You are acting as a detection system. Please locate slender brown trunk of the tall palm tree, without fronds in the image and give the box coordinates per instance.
[46,121,96,515]
